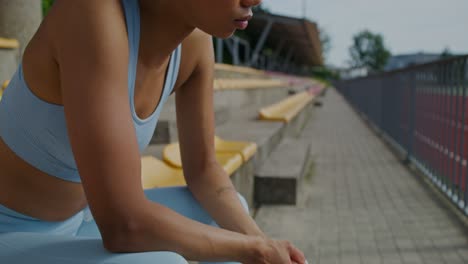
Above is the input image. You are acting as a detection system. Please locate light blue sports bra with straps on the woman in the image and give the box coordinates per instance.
[0,0,181,182]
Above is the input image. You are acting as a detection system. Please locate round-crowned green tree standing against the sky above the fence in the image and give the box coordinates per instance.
[349,30,391,72]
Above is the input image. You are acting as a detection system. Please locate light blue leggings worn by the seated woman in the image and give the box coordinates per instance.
[0,187,248,264]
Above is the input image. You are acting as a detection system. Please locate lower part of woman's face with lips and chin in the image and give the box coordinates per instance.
[184,0,262,38]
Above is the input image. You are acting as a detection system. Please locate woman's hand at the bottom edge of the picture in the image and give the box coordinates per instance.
[244,238,306,264]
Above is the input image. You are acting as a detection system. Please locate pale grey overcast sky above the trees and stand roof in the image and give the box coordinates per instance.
[263,0,468,66]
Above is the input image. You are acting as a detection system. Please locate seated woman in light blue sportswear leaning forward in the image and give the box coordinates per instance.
[0,0,305,264]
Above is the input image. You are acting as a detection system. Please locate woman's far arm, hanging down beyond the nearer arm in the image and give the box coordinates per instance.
[176,30,264,236]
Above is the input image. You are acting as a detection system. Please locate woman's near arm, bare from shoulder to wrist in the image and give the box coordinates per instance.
[54,0,264,263]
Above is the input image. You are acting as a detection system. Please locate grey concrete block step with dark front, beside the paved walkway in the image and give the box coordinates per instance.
[254,138,310,206]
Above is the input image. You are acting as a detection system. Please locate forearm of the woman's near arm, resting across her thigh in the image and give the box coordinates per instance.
[103,201,258,262]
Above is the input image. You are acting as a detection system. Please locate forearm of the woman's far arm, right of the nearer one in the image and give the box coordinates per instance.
[188,167,264,236]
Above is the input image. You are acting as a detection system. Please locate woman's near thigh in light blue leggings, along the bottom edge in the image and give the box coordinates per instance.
[0,233,187,264]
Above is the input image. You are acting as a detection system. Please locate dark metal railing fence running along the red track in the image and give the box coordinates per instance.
[335,56,468,215]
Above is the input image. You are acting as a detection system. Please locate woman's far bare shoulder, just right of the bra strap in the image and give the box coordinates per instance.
[176,29,214,87]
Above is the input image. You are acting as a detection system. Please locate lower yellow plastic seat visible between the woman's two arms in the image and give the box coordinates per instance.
[141,156,187,189]
